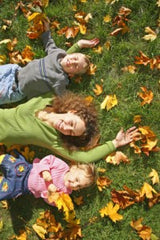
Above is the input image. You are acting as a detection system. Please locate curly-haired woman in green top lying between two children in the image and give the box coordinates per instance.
[0,92,138,163]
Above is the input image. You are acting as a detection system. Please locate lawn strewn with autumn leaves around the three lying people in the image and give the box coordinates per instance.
[0,0,160,240]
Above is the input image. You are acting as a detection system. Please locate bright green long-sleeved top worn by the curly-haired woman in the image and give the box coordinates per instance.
[0,93,115,163]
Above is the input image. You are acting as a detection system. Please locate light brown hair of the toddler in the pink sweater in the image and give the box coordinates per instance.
[72,163,97,187]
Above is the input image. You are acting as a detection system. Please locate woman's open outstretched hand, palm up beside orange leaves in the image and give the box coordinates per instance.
[112,127,140,148]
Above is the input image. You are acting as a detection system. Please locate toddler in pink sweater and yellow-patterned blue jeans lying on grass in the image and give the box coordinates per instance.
[0,153,96,205]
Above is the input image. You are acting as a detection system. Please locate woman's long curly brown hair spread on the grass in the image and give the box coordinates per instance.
[44,91,99,150]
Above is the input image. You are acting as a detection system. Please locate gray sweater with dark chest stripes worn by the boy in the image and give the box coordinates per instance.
[18,31,69,99]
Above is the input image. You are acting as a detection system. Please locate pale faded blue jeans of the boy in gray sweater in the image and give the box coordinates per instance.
[0,64,25,105]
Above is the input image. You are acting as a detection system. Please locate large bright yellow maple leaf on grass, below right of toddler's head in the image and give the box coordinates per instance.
[99,201,123,222]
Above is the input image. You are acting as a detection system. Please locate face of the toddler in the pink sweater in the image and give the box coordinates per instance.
[64,166,90,190]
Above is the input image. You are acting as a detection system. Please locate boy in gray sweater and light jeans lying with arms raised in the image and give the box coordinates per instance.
[0,18,99,104]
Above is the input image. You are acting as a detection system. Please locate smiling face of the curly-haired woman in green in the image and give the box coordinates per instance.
[54,112,86,136]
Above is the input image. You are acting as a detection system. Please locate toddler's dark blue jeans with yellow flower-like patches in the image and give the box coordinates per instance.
[0,153,32,201]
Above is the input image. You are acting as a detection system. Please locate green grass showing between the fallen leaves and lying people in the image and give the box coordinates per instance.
[0,0,160,240]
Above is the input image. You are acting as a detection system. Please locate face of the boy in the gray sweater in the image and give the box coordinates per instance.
[61,53,87,75]
